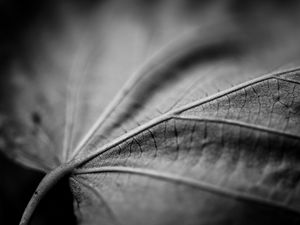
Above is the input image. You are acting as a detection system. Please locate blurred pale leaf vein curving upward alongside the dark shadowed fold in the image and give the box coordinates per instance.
[67,29,244,160]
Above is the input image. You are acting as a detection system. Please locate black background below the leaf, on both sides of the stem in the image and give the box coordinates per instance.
[0,153,76,225]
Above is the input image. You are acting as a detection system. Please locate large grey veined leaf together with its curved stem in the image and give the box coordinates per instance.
[1,1,300,224]
